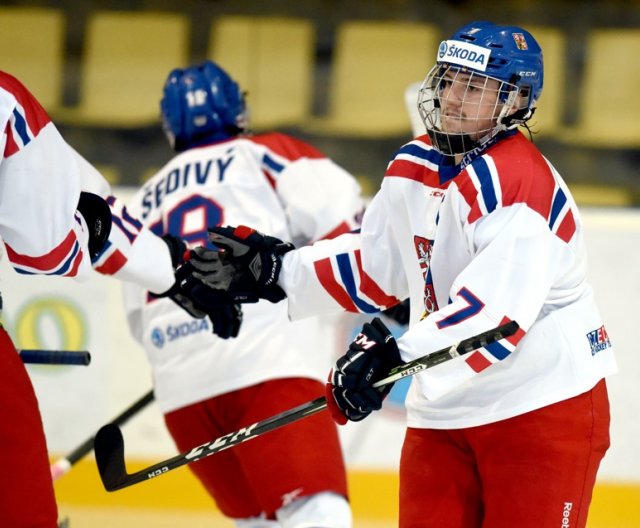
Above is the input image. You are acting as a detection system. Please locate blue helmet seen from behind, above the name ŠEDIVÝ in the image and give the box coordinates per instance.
[160,61,247,152]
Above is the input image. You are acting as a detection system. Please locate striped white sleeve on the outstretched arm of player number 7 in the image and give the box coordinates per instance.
[279,193,408,319]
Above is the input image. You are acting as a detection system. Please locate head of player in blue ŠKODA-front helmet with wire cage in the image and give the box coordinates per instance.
[418,22,543,156]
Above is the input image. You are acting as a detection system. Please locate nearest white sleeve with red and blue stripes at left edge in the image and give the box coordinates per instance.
[0,73,91,277]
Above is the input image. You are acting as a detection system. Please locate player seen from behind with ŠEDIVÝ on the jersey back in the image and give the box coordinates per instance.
[120,61,364,528]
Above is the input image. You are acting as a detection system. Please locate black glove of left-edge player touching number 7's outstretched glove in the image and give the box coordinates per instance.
[154,235,242,339]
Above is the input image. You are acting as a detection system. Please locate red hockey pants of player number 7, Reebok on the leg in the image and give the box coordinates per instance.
[400,380,609,528]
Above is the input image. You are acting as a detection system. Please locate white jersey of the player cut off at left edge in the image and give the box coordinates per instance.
[0,71,174,293]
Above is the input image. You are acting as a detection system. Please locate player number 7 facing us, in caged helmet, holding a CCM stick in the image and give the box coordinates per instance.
[204,22,616,528]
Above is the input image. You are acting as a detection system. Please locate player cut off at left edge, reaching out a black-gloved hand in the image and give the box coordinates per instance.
[0,71,229,528]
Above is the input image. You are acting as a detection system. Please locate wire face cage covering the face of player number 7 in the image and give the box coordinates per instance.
[418,63,526,156]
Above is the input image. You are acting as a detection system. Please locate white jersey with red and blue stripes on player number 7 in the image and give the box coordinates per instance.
[280,132,616,428]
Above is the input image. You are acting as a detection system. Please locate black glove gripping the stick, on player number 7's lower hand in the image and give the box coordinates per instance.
[326,317,402,425]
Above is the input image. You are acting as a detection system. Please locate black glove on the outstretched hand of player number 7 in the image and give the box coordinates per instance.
[207,226,294,303]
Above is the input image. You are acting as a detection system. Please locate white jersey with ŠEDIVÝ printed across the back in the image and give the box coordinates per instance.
[125,133,363,413]
